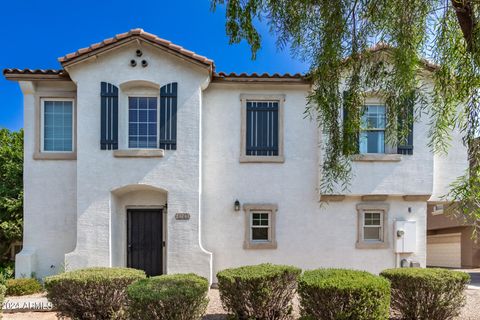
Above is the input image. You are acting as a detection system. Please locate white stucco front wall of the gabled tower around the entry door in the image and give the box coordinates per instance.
[62,44,210,277]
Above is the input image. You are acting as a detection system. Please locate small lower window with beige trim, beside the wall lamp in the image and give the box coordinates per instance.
[243,204,277,249]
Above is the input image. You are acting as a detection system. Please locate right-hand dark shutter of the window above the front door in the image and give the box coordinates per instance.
[159,82,178,150]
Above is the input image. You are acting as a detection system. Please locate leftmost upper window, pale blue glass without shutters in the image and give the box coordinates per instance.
[41,99,74,153]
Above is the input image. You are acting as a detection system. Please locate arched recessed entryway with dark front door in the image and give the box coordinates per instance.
[111,184,168,276]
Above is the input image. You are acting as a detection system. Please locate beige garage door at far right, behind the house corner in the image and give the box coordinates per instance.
[427,233,462,268]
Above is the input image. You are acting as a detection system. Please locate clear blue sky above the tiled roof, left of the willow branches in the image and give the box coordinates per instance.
[0,0,308,130]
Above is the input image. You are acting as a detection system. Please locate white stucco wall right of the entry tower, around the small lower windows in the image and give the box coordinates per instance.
[202,84,432,280]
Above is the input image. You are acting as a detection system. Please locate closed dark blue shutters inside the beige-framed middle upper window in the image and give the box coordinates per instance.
[245,101,279,156]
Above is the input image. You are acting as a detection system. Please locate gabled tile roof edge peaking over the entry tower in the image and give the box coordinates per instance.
[58,29,215,72]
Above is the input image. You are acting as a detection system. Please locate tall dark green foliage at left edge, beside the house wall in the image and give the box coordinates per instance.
[0,129,23,261]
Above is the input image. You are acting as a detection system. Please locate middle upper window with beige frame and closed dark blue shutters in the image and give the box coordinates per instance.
[240,95,285,162]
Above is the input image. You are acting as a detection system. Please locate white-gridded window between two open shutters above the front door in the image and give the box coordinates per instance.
[128,97,158,148]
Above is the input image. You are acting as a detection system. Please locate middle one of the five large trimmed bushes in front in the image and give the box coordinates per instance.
[217,264,302,320]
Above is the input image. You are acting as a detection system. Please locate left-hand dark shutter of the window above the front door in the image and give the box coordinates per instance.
[100,82,118,150]
